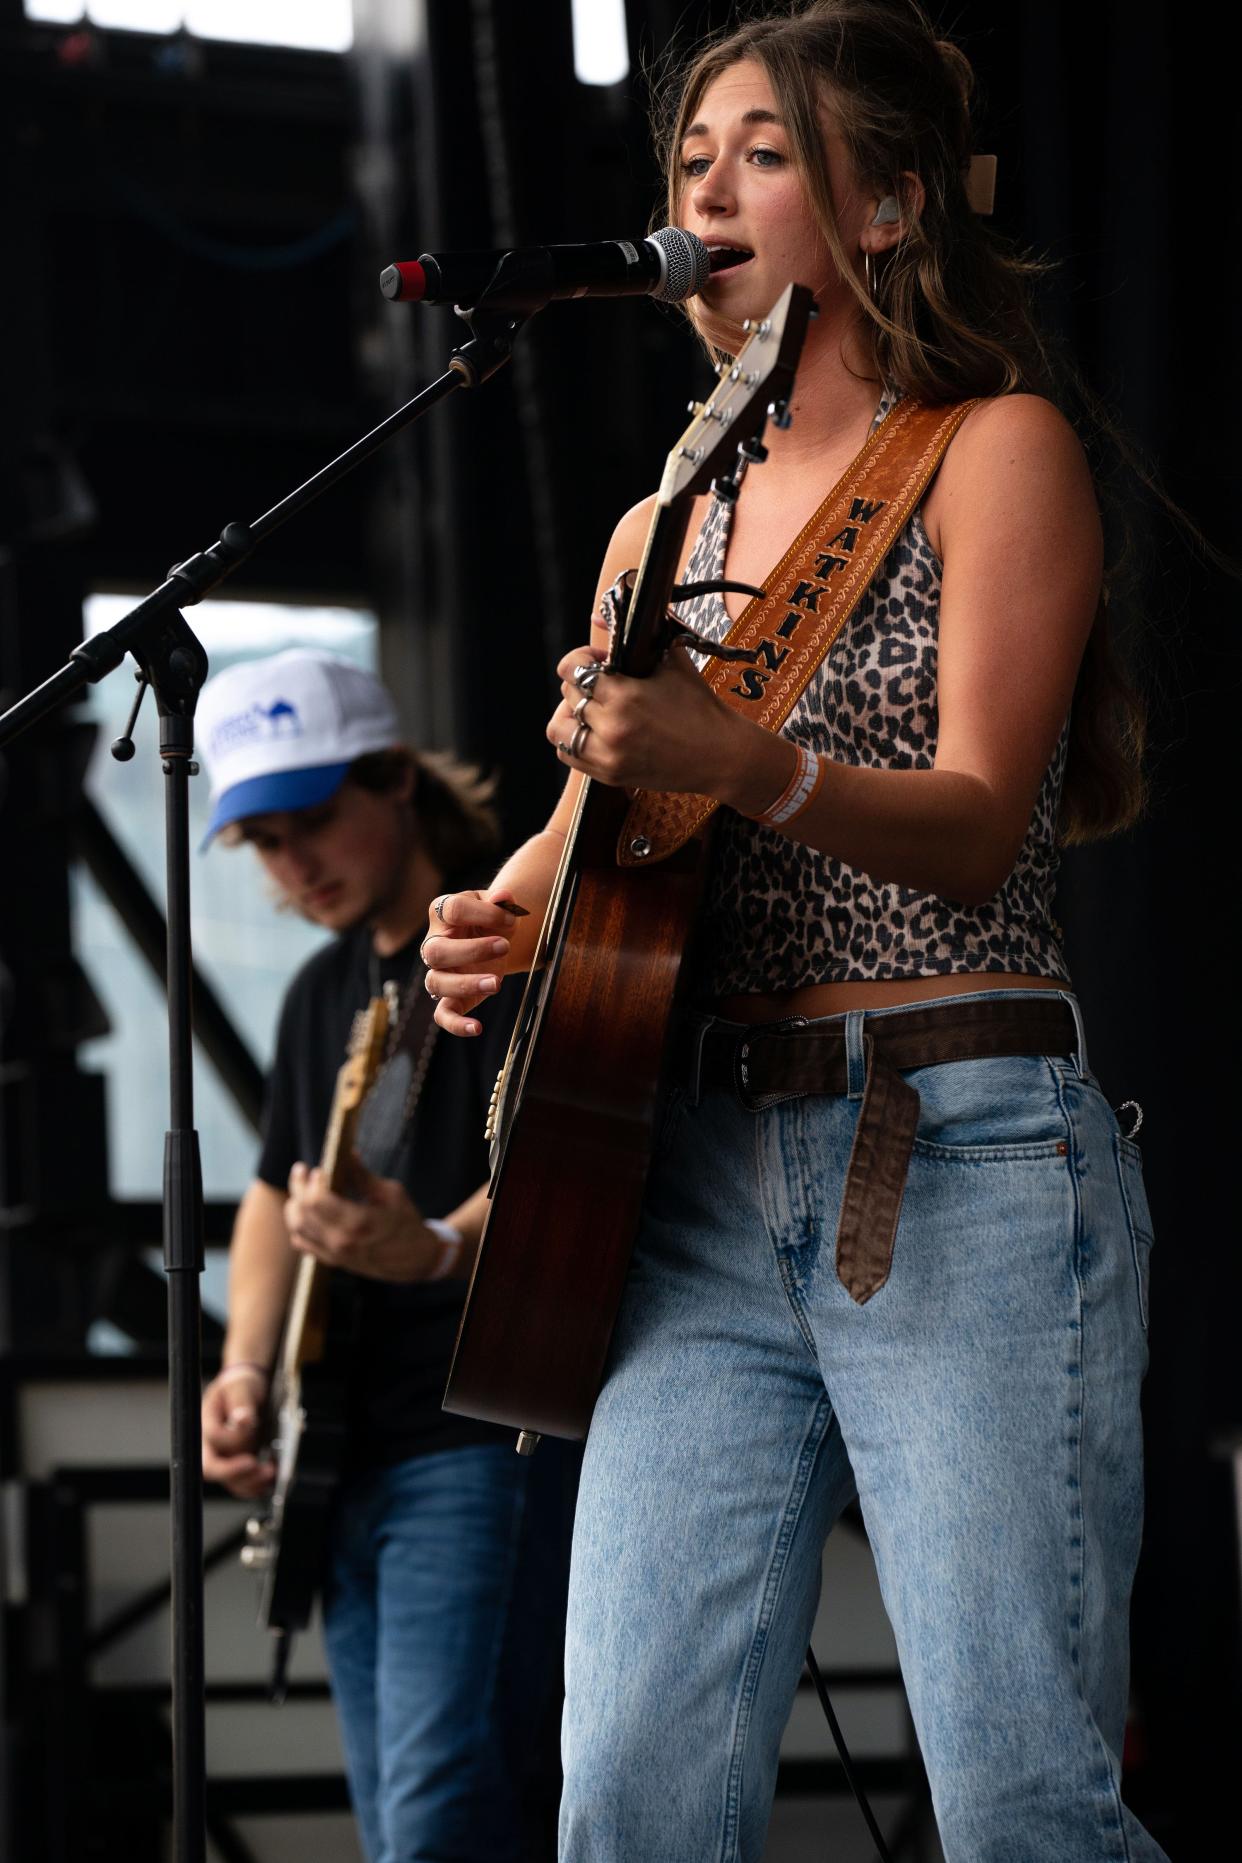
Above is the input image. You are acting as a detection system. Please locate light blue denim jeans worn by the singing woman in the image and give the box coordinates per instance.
[560,993,1164,1863]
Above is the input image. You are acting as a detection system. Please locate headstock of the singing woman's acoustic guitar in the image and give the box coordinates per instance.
[657,285,816,505]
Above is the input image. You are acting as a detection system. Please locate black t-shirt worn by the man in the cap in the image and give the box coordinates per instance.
[257,928,521,1468]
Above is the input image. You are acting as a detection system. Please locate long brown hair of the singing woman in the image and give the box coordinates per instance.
[655,0,1145,844]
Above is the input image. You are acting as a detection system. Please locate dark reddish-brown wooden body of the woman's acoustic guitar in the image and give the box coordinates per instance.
[445,784,706,1438]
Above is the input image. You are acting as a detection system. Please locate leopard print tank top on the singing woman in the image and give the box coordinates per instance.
[678,393,1069,997]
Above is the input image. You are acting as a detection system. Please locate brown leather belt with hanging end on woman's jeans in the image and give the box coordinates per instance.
[670,991,1078,1306]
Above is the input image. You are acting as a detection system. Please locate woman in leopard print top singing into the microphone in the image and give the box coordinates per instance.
[426,0,1164,1863]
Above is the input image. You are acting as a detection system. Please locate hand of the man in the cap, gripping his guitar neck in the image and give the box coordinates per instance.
[285,1159,482,1282]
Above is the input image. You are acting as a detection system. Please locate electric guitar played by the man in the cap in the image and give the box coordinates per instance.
[242,997,389,1699]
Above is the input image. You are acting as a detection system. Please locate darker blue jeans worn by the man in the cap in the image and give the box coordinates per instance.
[324,1444,572,1863]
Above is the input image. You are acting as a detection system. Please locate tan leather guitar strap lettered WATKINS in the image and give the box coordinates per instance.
[616,401,978,866]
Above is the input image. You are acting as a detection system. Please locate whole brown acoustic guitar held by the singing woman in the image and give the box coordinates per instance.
[445,285,812,1451]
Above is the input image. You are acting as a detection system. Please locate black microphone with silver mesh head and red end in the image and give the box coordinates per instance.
[380,227,711,311]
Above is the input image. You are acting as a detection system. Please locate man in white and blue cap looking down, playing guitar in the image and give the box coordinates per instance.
[199,650,570,1863]
